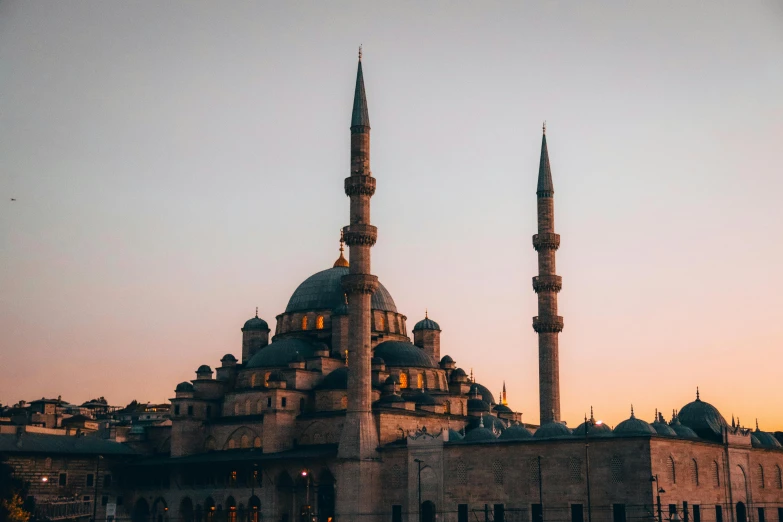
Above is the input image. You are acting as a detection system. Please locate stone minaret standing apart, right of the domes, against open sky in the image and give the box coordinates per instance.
[533,122,563,425]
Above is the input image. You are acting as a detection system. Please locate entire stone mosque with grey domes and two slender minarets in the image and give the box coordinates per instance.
[122,54,783,522]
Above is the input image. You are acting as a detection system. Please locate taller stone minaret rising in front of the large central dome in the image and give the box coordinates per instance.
[338,48,378,459]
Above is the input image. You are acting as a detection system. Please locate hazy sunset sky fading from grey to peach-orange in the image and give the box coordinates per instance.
[0,1,783,430]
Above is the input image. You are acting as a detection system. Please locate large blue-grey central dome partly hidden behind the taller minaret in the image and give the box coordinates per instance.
[285,266,397,313]
